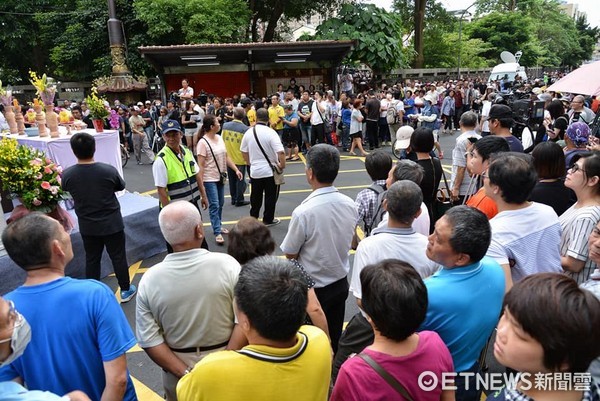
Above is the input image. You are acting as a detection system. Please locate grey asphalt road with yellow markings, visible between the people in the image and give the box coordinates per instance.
[104,133,496,401]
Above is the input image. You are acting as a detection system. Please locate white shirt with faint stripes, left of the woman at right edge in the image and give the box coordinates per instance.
[487,202,563,283]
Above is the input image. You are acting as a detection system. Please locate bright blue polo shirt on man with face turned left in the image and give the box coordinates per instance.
[418,257,505,372]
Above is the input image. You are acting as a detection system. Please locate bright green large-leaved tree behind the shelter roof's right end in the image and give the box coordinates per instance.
[313,4,407,72]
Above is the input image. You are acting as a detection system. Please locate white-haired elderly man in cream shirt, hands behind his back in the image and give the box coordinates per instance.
[135,201,243,401]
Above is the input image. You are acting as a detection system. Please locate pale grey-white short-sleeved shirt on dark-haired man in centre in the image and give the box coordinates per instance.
[281,186,358,288]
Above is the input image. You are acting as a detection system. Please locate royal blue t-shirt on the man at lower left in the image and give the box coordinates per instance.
[0,277,137,401]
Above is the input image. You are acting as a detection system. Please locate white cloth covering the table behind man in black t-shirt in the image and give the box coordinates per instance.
[2,127,124,178]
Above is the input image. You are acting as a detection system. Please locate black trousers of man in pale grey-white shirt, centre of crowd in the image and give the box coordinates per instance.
[315,277,349,352]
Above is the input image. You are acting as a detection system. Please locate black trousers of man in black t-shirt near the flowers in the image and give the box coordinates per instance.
[81,230,129,291]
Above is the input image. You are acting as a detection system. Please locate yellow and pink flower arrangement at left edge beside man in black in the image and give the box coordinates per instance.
[0,138,71,213]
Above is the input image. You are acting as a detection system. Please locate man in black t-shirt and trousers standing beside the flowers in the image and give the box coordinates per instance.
[62,132,137,302]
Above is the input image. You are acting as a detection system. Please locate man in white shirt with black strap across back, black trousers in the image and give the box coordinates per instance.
[241,108,285,226]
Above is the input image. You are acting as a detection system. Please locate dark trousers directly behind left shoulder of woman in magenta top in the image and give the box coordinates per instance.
[331,312,375,384]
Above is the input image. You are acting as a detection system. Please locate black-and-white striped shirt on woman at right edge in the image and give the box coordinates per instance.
[559,205,600,284]
